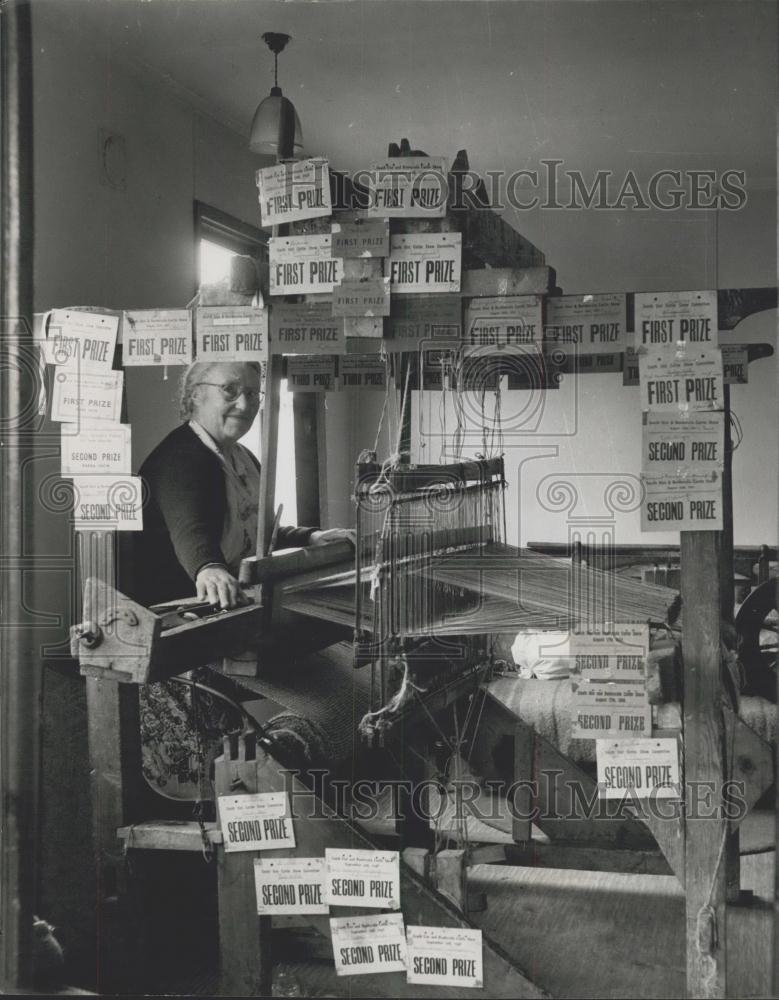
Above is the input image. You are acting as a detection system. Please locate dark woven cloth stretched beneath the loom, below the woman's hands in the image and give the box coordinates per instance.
[241,642,370,764]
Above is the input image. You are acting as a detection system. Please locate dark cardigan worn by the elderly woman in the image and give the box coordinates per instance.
[132,424,316,606]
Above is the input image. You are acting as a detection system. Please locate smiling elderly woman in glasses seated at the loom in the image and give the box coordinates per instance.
[137,362,350,608]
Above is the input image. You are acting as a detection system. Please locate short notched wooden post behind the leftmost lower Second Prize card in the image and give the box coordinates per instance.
[214,735,273,997]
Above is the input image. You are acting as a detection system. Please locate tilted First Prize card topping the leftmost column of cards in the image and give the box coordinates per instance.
[44,309,119,372]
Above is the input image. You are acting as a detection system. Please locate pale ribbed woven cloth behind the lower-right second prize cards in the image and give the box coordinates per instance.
[487,677,776,762]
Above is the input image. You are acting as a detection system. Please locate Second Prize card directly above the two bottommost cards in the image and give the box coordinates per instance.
[325,847,400,910]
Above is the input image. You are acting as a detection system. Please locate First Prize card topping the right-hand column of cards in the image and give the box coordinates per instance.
[633,291,717,348]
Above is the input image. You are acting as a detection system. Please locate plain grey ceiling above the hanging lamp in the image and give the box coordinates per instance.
[35,0,777,187]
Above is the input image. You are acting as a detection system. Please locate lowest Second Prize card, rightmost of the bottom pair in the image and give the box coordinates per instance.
[406,925,484,989]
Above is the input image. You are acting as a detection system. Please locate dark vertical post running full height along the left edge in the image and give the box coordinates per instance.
[0,2,36,993]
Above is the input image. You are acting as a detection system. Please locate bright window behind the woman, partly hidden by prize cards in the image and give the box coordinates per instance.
[195,202,297,524]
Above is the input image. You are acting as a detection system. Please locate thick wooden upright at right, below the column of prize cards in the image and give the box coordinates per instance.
[681,531,728,997]
